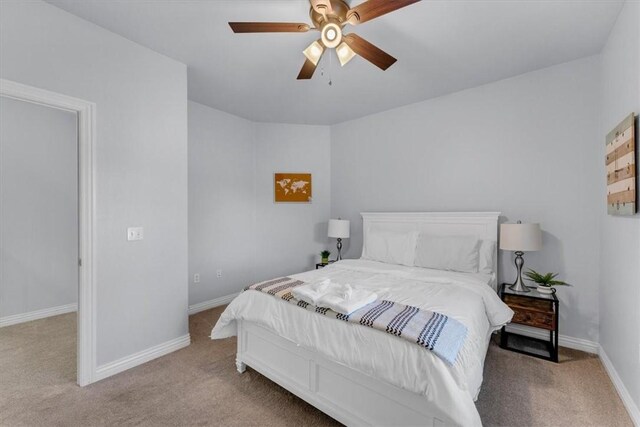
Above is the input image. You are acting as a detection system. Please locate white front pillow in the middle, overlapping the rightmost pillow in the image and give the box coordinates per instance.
[415,234,480,273]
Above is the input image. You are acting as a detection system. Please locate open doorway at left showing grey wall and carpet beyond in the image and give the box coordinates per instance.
[0,96,78,389]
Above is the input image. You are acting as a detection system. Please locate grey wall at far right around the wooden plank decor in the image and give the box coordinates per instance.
[598,1,640,414]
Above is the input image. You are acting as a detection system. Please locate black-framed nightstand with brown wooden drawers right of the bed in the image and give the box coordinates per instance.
[500,283,560,363]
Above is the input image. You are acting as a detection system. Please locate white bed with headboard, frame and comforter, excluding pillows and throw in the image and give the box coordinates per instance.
[212,212,513,426]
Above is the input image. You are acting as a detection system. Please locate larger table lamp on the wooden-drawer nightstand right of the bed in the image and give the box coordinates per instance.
[500,221,542,292]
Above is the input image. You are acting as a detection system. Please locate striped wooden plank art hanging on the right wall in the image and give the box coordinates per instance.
[606,113,638,215]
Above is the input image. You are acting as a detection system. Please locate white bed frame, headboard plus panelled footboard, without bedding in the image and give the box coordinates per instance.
[236,212,500,426]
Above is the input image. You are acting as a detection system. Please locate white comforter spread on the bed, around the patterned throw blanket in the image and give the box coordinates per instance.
[211,260,513,426]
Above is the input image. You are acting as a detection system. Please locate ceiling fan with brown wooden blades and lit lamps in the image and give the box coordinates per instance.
[229,0,420,80]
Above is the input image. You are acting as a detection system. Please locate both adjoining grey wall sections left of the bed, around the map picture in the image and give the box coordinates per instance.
[189,102,330,305]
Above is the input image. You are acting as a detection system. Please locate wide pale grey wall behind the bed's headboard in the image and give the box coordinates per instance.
[331,57,602,341]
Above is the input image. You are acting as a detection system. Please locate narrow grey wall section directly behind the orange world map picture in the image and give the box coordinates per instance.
[255,123,335,280]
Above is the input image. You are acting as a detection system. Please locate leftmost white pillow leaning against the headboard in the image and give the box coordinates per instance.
[362,231,418,266]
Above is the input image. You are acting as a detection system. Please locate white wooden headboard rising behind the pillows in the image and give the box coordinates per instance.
[360,212,500,285]
